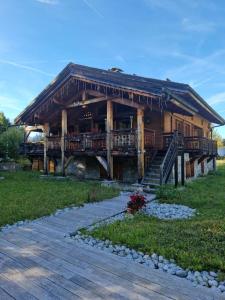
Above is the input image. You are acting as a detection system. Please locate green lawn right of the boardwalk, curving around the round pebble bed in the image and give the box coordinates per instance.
[89,161,225,273]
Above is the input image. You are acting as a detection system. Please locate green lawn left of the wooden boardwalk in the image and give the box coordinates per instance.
[0,172,118,227]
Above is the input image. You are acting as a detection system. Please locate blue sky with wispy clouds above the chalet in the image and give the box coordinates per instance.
[0,0,225,138]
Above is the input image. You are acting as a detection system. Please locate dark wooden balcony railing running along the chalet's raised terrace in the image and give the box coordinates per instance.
[20,129,217,156]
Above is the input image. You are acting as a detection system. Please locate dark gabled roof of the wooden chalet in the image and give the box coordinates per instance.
[15,63,225,125]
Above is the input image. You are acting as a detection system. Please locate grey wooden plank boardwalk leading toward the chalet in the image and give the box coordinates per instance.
[0,197,225,300]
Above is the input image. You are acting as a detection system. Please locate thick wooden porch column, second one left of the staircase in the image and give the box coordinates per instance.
[106,101,113,179]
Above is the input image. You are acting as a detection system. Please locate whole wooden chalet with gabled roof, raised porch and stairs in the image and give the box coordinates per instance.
[15,63,225,187]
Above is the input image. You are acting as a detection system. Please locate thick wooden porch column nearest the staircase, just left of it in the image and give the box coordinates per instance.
[137,108,145,181]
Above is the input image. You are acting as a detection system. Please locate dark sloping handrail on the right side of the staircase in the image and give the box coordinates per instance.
[160,131,180,184]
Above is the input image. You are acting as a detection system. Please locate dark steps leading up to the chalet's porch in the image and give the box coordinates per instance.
[142,151,165,193]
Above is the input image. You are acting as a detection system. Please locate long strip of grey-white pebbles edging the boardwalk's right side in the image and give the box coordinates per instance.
[70,231,225,294]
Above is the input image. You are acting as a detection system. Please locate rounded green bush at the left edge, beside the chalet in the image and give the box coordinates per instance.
[0,127,24,159]
